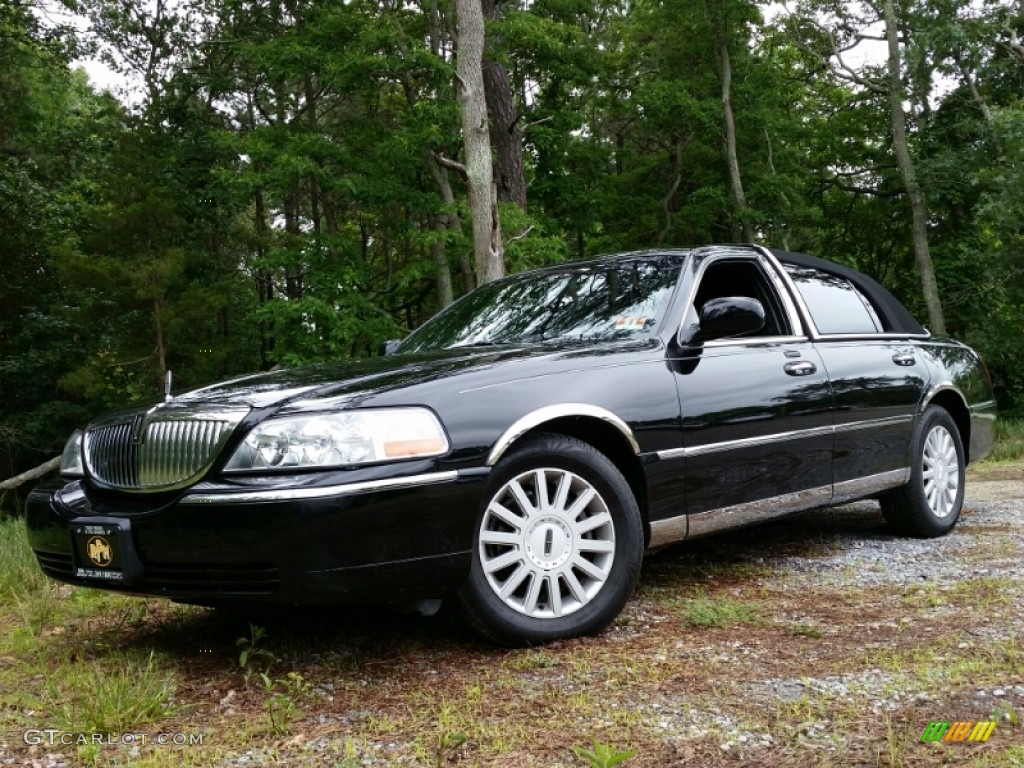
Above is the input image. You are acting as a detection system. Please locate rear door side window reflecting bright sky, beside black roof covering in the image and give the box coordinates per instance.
[785,264,883,334]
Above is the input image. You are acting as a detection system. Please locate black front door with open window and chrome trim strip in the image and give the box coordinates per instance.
[671,252,834,537]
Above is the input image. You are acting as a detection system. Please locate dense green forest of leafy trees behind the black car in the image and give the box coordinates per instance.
[0,0,1024,509]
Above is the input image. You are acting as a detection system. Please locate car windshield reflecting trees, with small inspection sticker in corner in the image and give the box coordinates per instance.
[396,259,679,354]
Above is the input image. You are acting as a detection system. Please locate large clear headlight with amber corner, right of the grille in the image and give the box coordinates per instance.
[224,408,449,472]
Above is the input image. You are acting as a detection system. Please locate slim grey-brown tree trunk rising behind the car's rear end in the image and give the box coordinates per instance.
[882,0,946,336]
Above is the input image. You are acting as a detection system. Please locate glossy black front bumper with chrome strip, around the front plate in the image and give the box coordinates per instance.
[26,470,486,604]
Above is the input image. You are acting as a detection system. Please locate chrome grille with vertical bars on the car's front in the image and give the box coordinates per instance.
[84,409,248,490]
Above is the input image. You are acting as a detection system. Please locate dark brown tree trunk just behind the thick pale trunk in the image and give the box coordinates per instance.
[481,0,526,210]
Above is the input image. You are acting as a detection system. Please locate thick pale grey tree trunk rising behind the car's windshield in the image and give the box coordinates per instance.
[456,0,505,285]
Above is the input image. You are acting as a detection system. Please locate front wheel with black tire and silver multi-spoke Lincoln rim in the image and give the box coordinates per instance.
[459,434,644,646]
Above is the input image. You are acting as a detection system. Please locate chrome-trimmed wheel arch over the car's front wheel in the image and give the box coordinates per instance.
[487,403,650,544]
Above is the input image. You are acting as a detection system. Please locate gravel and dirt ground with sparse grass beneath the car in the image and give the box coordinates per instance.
[0,465,1024,768]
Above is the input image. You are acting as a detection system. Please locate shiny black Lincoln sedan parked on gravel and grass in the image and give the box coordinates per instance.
[27,246,995,643]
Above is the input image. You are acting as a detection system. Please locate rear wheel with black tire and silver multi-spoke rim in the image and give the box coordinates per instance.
[880,406,967,539]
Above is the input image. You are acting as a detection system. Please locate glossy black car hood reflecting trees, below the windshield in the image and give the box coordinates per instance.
[161,339,657,410]
